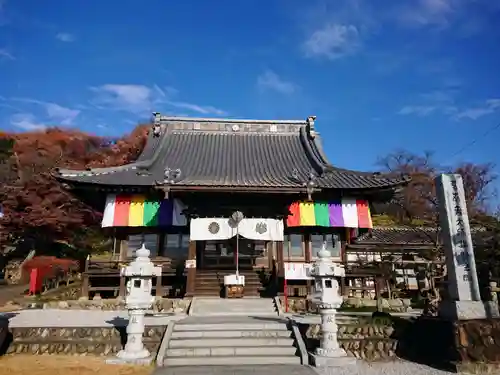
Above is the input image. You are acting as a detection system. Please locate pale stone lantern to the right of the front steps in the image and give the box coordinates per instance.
[309,245,356,367]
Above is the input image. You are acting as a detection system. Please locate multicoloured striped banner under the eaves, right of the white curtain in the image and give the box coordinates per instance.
[286,198,373,228]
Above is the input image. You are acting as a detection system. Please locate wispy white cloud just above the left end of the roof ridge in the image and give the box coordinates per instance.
[91,84,226,115]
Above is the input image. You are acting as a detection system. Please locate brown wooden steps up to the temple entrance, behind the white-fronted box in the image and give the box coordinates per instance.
[195,270,262,297]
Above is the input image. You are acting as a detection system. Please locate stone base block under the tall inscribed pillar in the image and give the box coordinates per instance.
[439,300,500,320]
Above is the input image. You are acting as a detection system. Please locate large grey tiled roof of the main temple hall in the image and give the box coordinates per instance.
[58,117,406,189]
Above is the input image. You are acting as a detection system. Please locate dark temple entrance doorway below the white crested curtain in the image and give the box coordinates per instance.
[203,236,258,270]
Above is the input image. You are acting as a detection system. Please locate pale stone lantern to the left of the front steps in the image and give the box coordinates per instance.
[106,244,161,365]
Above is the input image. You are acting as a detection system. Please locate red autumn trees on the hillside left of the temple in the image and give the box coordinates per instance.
[0,125,148,250]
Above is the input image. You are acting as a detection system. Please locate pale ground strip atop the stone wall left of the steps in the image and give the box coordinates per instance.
[0,309,185,327]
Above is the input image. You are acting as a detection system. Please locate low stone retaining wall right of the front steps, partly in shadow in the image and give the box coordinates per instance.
[299,316,500,370]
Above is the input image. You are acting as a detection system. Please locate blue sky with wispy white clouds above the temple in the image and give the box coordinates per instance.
[0,0,500,200]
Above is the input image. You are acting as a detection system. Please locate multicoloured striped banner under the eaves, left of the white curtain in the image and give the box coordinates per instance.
[101,194,187,228]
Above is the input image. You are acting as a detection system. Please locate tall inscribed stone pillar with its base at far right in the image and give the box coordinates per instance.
[435,174,499,320]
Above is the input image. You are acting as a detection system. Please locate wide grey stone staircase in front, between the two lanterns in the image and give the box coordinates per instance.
[161,318,301,366]
